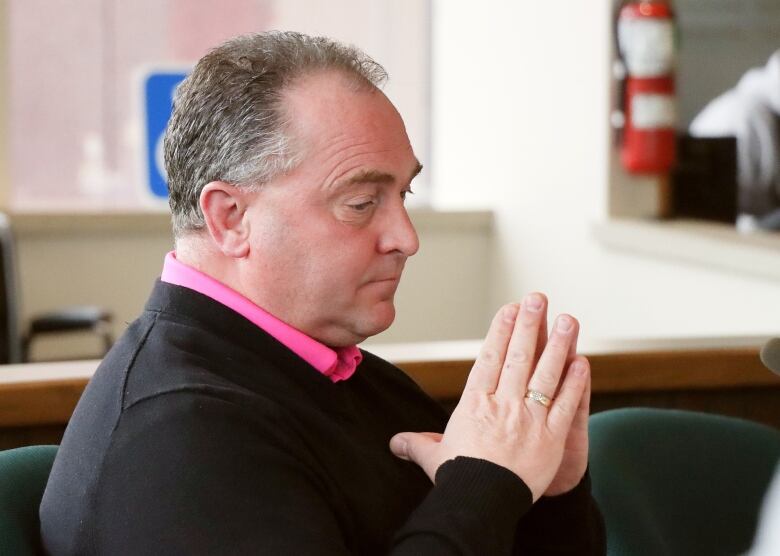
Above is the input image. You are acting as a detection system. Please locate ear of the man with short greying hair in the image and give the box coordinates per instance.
[199,181,249,258]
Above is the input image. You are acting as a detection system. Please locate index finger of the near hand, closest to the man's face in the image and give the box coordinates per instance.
[465,303,518,394]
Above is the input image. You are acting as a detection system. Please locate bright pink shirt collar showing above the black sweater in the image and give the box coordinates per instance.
[160,251,363,382]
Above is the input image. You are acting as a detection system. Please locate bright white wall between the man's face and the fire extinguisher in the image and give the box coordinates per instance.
[432,0,780,344]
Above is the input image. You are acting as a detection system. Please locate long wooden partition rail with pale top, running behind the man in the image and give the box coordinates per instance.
[0,337,780,449]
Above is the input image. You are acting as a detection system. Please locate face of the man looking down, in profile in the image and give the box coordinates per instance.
[241,73,421,346]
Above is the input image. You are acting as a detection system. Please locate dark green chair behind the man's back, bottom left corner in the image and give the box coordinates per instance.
[0,446,57,556]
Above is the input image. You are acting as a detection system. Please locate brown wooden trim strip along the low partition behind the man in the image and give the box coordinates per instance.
[0,338,780,428]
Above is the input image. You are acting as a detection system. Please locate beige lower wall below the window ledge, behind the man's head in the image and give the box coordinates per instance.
[12,210,492,359]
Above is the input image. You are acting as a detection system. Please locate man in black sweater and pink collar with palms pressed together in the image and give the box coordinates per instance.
[41,33,603,555]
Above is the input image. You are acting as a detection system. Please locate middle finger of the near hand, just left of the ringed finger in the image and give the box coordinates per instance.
[496,293,547,399]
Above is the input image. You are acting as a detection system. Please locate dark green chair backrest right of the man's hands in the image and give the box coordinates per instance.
[590,408,780,556]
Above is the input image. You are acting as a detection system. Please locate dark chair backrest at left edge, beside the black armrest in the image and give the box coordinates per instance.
[0,213,22,364]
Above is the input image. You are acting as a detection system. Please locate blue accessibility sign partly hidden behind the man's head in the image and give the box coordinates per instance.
[143,71,187,199]
